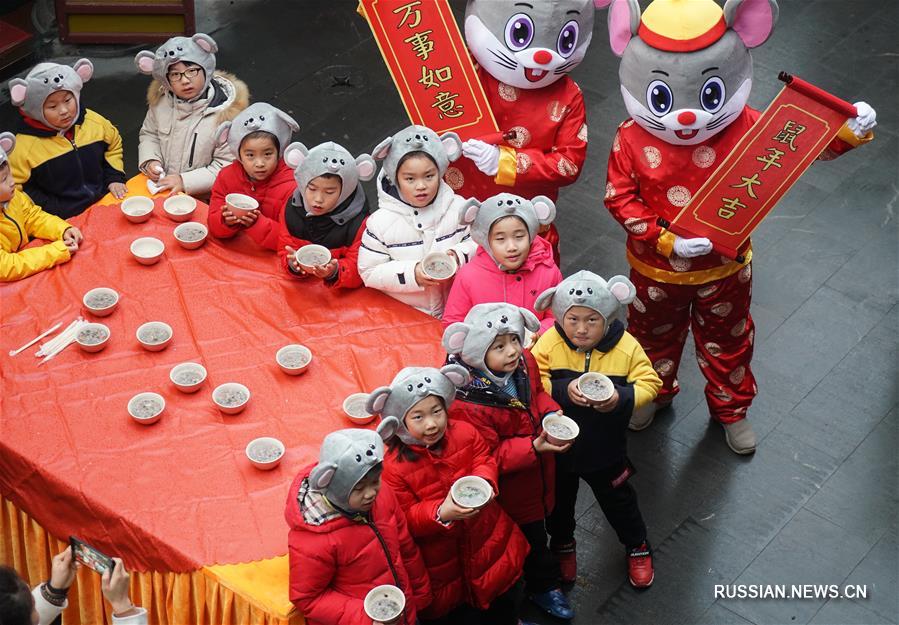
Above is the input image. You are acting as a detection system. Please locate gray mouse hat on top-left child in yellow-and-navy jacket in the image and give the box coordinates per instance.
[9,59,94,130]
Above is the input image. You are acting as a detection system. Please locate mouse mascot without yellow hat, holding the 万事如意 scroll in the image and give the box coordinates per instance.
[454,0,609,264]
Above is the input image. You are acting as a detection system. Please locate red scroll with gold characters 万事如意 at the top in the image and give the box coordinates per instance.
[359,0,497,140]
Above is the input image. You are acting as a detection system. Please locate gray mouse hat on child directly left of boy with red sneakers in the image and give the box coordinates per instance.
[443,303,540,373]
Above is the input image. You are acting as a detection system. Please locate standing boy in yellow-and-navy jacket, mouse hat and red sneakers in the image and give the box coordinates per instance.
[532,271,662,588]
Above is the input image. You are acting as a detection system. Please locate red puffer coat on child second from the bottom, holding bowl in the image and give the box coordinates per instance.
[384,420,530,619]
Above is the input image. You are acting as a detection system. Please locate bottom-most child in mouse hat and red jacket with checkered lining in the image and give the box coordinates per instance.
[284,427,431,625]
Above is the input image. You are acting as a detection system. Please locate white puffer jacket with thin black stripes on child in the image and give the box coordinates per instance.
[359,170,477,319]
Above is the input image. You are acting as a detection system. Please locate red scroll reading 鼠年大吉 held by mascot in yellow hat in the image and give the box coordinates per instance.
[662,74,856,259]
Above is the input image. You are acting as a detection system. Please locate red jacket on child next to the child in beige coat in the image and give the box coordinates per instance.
[207,160,297,250]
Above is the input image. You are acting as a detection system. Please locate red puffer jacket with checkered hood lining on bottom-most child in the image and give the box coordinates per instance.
[284,465,431,625]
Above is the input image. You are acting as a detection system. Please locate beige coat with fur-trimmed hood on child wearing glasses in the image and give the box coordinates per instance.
[138,72,250,195]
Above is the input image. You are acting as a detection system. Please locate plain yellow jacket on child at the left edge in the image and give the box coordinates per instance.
[0,191,71,282]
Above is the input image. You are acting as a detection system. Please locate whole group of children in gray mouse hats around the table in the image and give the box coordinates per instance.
[0,20,864,625]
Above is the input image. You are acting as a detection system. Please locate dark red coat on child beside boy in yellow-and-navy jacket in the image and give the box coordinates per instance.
[450,350,559,525]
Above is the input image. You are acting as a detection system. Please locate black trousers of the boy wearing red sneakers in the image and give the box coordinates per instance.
[546,470,646,548]
